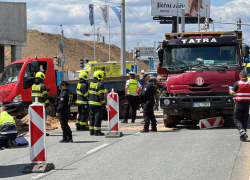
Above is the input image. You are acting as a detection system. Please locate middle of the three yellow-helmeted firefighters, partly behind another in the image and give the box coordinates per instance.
[76,71,89,131]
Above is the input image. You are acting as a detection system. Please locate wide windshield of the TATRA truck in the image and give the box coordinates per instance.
[163,45,239,68]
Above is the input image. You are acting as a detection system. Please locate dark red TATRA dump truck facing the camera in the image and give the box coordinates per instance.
[157,31,249,127]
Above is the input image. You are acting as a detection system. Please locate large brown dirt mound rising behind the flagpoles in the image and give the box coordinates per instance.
[5,30,149,72]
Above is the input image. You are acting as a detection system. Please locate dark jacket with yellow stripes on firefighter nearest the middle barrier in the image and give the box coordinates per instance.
[89,79,105,106]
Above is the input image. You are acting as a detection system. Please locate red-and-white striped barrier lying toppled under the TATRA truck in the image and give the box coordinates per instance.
[197,117,224,129]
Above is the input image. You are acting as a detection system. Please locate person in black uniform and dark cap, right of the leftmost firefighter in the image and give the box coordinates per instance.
[56,81,73,143]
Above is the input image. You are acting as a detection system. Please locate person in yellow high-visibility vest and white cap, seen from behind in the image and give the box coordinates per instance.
[121,72,141,123]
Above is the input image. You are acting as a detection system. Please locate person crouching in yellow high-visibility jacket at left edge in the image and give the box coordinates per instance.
[0,107,17,148]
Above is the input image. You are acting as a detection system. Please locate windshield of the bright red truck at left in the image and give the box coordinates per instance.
[0,63,23,85]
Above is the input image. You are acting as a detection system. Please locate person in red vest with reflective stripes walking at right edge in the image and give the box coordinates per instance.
[229,71,250,141]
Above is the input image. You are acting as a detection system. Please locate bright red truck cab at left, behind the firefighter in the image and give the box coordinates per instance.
[0,57,58,116]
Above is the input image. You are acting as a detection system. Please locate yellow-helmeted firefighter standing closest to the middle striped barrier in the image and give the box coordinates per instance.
[89,71,105,136]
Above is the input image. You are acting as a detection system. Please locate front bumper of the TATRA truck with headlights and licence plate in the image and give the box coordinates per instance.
[160,95,234,109]
